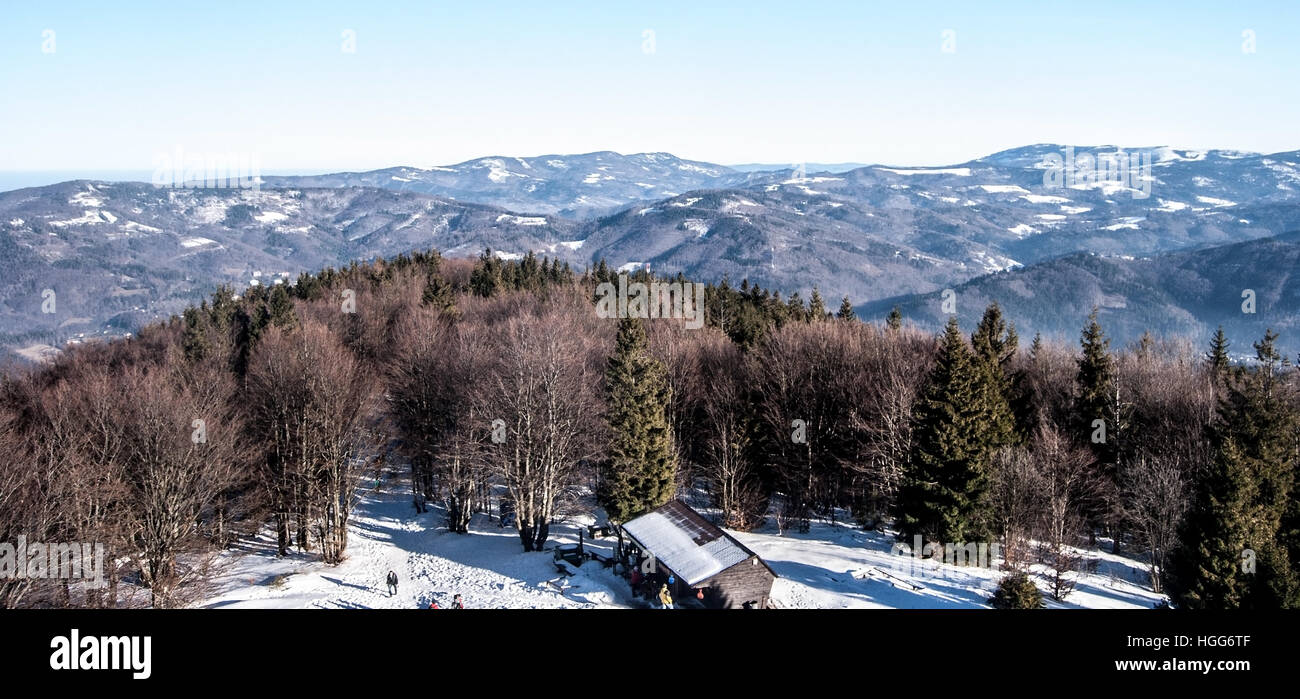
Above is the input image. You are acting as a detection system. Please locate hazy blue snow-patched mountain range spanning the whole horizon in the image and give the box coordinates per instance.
[0,144,1300,355]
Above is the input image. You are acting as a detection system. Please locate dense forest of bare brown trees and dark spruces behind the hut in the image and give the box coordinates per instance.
[0,252,1300,608]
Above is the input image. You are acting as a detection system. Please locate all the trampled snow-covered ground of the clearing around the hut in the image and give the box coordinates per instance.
[194,467,1164,609]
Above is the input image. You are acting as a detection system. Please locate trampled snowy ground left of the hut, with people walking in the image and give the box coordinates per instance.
[195,470,640,609]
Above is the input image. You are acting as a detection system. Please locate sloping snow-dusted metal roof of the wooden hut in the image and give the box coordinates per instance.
[623,500,754,585]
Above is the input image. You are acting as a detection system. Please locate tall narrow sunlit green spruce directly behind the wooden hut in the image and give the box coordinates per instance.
[598,318,677,522]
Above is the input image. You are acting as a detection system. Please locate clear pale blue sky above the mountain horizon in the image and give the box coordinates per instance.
[0,0,1300,172]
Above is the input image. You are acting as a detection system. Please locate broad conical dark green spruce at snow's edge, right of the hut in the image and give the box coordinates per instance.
[896,317,991,543]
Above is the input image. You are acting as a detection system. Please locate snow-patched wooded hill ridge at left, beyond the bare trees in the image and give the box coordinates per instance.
[0,181,576,347]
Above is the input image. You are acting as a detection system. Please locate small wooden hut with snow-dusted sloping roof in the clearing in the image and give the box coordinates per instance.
[623,500,776,609]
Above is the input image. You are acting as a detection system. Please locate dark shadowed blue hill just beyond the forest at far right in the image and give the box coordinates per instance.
[862,231,1300,353]
